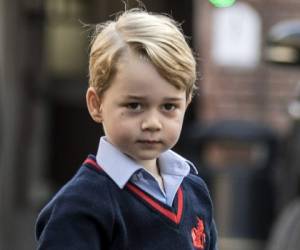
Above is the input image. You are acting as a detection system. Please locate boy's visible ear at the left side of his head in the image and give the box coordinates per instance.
[86,87,102,123]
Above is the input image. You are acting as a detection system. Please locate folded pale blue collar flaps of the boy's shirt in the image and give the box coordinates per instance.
[96,136,198,188]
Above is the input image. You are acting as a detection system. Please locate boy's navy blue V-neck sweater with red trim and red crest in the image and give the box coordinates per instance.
[36,156,217,250]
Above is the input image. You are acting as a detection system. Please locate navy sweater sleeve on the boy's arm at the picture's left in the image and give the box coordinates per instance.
[36,171,113,250]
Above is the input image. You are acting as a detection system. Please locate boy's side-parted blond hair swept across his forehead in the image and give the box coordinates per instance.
[89,9,196,97]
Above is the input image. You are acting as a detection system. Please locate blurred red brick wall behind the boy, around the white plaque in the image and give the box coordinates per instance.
[194,0,300,133]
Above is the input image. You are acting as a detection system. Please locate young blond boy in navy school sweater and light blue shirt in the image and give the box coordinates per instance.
[36,10,217,250]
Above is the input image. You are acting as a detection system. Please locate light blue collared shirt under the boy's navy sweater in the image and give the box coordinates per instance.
[96,136,197,206]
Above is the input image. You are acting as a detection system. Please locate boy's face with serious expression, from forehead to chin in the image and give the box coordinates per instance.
[94,55,188,169]
